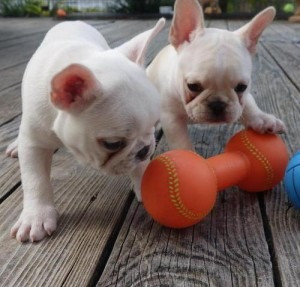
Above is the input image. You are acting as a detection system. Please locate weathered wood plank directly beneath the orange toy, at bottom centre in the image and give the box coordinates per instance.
[98,21,278,287]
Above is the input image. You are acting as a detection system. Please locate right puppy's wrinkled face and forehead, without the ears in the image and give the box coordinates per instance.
[178,29,252,123]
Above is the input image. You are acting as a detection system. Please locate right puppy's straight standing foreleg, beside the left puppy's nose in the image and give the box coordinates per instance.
[160,112,194,150]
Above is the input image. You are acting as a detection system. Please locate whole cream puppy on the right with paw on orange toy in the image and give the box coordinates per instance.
[147,0,285,152]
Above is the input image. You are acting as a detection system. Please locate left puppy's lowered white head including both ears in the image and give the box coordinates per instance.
[51,19,163,174]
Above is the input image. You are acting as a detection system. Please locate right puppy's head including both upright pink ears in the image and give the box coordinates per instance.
[169,0,275,123]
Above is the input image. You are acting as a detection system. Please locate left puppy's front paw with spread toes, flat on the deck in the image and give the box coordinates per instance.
[10,205,58,242]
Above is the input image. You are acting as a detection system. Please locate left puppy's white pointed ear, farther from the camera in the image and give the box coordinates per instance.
[117,18,166,66]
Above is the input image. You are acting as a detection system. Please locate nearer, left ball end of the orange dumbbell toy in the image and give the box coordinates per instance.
[142,150,217,228]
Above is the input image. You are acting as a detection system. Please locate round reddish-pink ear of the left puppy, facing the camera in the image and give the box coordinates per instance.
[51,64,100,112]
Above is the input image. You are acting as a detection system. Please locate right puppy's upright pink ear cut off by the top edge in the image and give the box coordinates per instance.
[169,0,205,48]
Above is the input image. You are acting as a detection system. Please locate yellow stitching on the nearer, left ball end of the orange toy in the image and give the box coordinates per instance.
[157,155,203,220]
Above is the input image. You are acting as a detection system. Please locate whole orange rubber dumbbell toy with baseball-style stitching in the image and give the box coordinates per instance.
[142,130,288,228]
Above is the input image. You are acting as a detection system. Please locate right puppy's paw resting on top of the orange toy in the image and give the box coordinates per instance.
[245,113,286,133]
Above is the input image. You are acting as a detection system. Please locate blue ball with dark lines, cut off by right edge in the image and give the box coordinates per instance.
[284,151,300,209]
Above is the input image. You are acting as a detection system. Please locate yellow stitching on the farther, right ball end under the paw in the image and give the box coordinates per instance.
[241,131,274,188]
